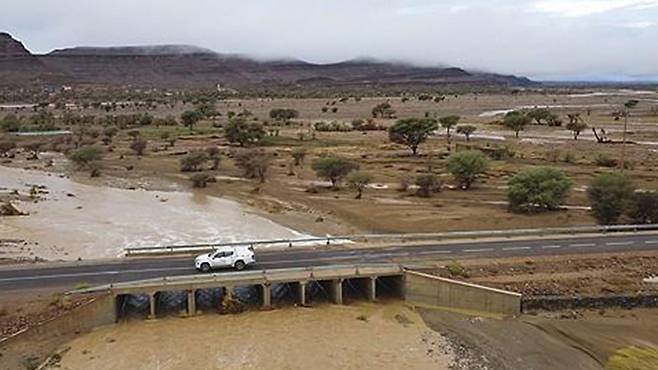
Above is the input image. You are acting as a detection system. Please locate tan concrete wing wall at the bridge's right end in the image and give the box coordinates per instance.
[404,271,521,316]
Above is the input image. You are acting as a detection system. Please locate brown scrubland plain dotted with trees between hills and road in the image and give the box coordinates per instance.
[0,86,658,231]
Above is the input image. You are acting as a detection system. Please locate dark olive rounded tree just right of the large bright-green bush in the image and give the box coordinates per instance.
[587,173,635,225]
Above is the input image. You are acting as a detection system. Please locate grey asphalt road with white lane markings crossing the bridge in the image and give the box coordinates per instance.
[0,233,658,294]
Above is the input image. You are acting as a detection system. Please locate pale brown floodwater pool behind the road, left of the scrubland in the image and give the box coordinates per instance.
[0,167,305,260]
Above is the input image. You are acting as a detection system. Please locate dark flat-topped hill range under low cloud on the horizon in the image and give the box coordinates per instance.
[0,33,532,88]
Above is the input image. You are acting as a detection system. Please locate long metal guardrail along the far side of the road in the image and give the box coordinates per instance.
[124,224,658,256]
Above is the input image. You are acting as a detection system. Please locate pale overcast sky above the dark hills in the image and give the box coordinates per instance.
[0,0,658,79]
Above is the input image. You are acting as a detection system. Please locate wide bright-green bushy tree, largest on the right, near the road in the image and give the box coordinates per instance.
[507,167,573,212]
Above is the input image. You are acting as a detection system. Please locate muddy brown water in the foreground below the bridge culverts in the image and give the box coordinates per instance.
[41,304,453,370]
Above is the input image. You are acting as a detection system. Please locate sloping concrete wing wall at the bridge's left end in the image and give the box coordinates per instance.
[0,295,116,369]
